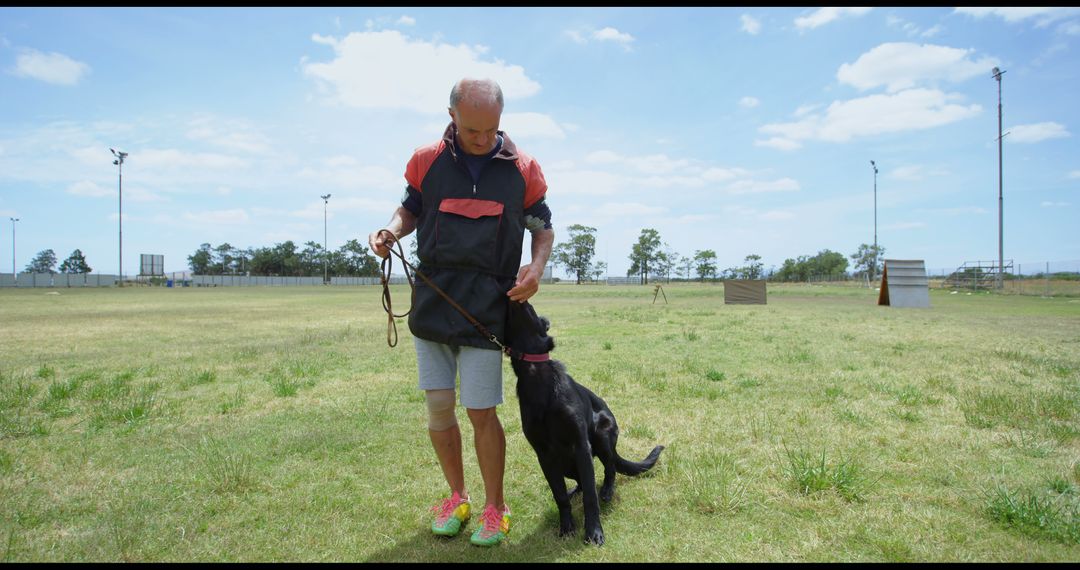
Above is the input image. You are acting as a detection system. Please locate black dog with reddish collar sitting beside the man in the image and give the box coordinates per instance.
[507,301,664,545]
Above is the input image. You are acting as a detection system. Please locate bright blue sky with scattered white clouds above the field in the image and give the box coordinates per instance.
[0,6,1080,275]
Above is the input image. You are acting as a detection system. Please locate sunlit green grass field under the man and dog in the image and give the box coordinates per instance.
[0,285,1080,561]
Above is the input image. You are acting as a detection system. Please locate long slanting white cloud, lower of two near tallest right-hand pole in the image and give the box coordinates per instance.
[756,89,982,148]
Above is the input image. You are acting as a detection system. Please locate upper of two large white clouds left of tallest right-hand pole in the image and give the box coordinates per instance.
[836,42,998,93]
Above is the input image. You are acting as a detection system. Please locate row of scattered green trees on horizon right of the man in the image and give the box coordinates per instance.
[551,223,885,284]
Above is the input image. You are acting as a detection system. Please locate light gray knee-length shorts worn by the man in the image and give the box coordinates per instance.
[413,337,502,409]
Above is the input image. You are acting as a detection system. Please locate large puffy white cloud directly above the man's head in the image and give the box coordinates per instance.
[301,30,540,114]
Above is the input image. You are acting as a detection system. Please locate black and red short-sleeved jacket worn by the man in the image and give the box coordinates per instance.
[405,123,548,350]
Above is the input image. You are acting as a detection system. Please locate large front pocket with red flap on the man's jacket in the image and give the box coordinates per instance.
[435,198,502,271]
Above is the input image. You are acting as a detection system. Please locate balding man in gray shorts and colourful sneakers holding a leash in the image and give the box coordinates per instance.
[368,79,555,546]
